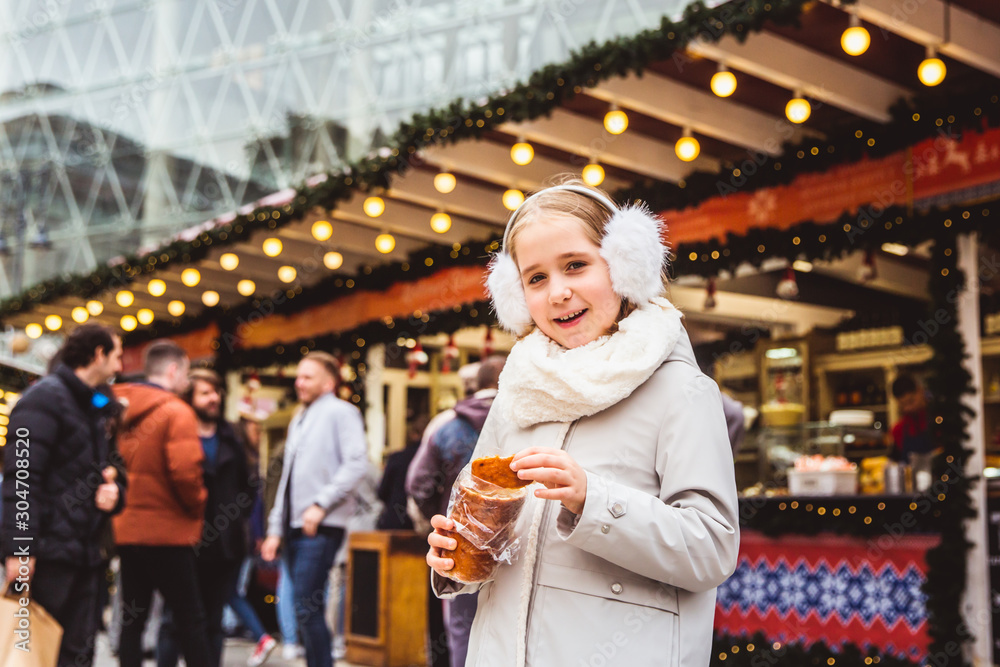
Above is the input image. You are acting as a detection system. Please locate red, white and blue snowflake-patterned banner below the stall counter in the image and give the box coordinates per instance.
[715,531,939,660]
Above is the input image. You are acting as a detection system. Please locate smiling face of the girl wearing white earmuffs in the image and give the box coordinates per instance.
[517,213,621,349]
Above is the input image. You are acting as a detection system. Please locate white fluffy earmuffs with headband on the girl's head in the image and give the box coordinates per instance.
[486,185,667,336]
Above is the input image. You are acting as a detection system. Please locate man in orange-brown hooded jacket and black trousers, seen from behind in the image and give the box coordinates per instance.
[114,341,210,667]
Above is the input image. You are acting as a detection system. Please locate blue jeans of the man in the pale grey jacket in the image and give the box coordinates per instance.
[285,527,344,667]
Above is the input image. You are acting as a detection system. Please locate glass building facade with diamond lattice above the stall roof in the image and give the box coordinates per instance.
[0,0,700,297]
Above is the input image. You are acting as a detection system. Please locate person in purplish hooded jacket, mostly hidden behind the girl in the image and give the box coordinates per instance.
[406,356,504,667]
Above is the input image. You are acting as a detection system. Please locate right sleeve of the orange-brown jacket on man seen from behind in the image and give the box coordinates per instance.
[164,404,208,518]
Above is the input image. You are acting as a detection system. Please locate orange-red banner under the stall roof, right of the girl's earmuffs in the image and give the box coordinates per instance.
[662,129,1000,246]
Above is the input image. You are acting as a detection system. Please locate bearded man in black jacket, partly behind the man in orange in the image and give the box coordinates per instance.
[156,368,256,667]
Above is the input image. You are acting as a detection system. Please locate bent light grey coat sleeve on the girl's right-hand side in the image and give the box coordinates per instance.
[557,374,739,592]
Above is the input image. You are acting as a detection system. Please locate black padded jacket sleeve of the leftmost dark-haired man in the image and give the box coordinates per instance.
[3,392,61,556]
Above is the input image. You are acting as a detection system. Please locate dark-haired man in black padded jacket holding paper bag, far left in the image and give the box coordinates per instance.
[2,324,125,667]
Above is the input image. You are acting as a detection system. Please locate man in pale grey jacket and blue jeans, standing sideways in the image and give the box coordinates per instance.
[260,352,368,667]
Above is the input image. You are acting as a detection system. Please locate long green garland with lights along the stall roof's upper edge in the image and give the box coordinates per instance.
[0,0,824,318]
